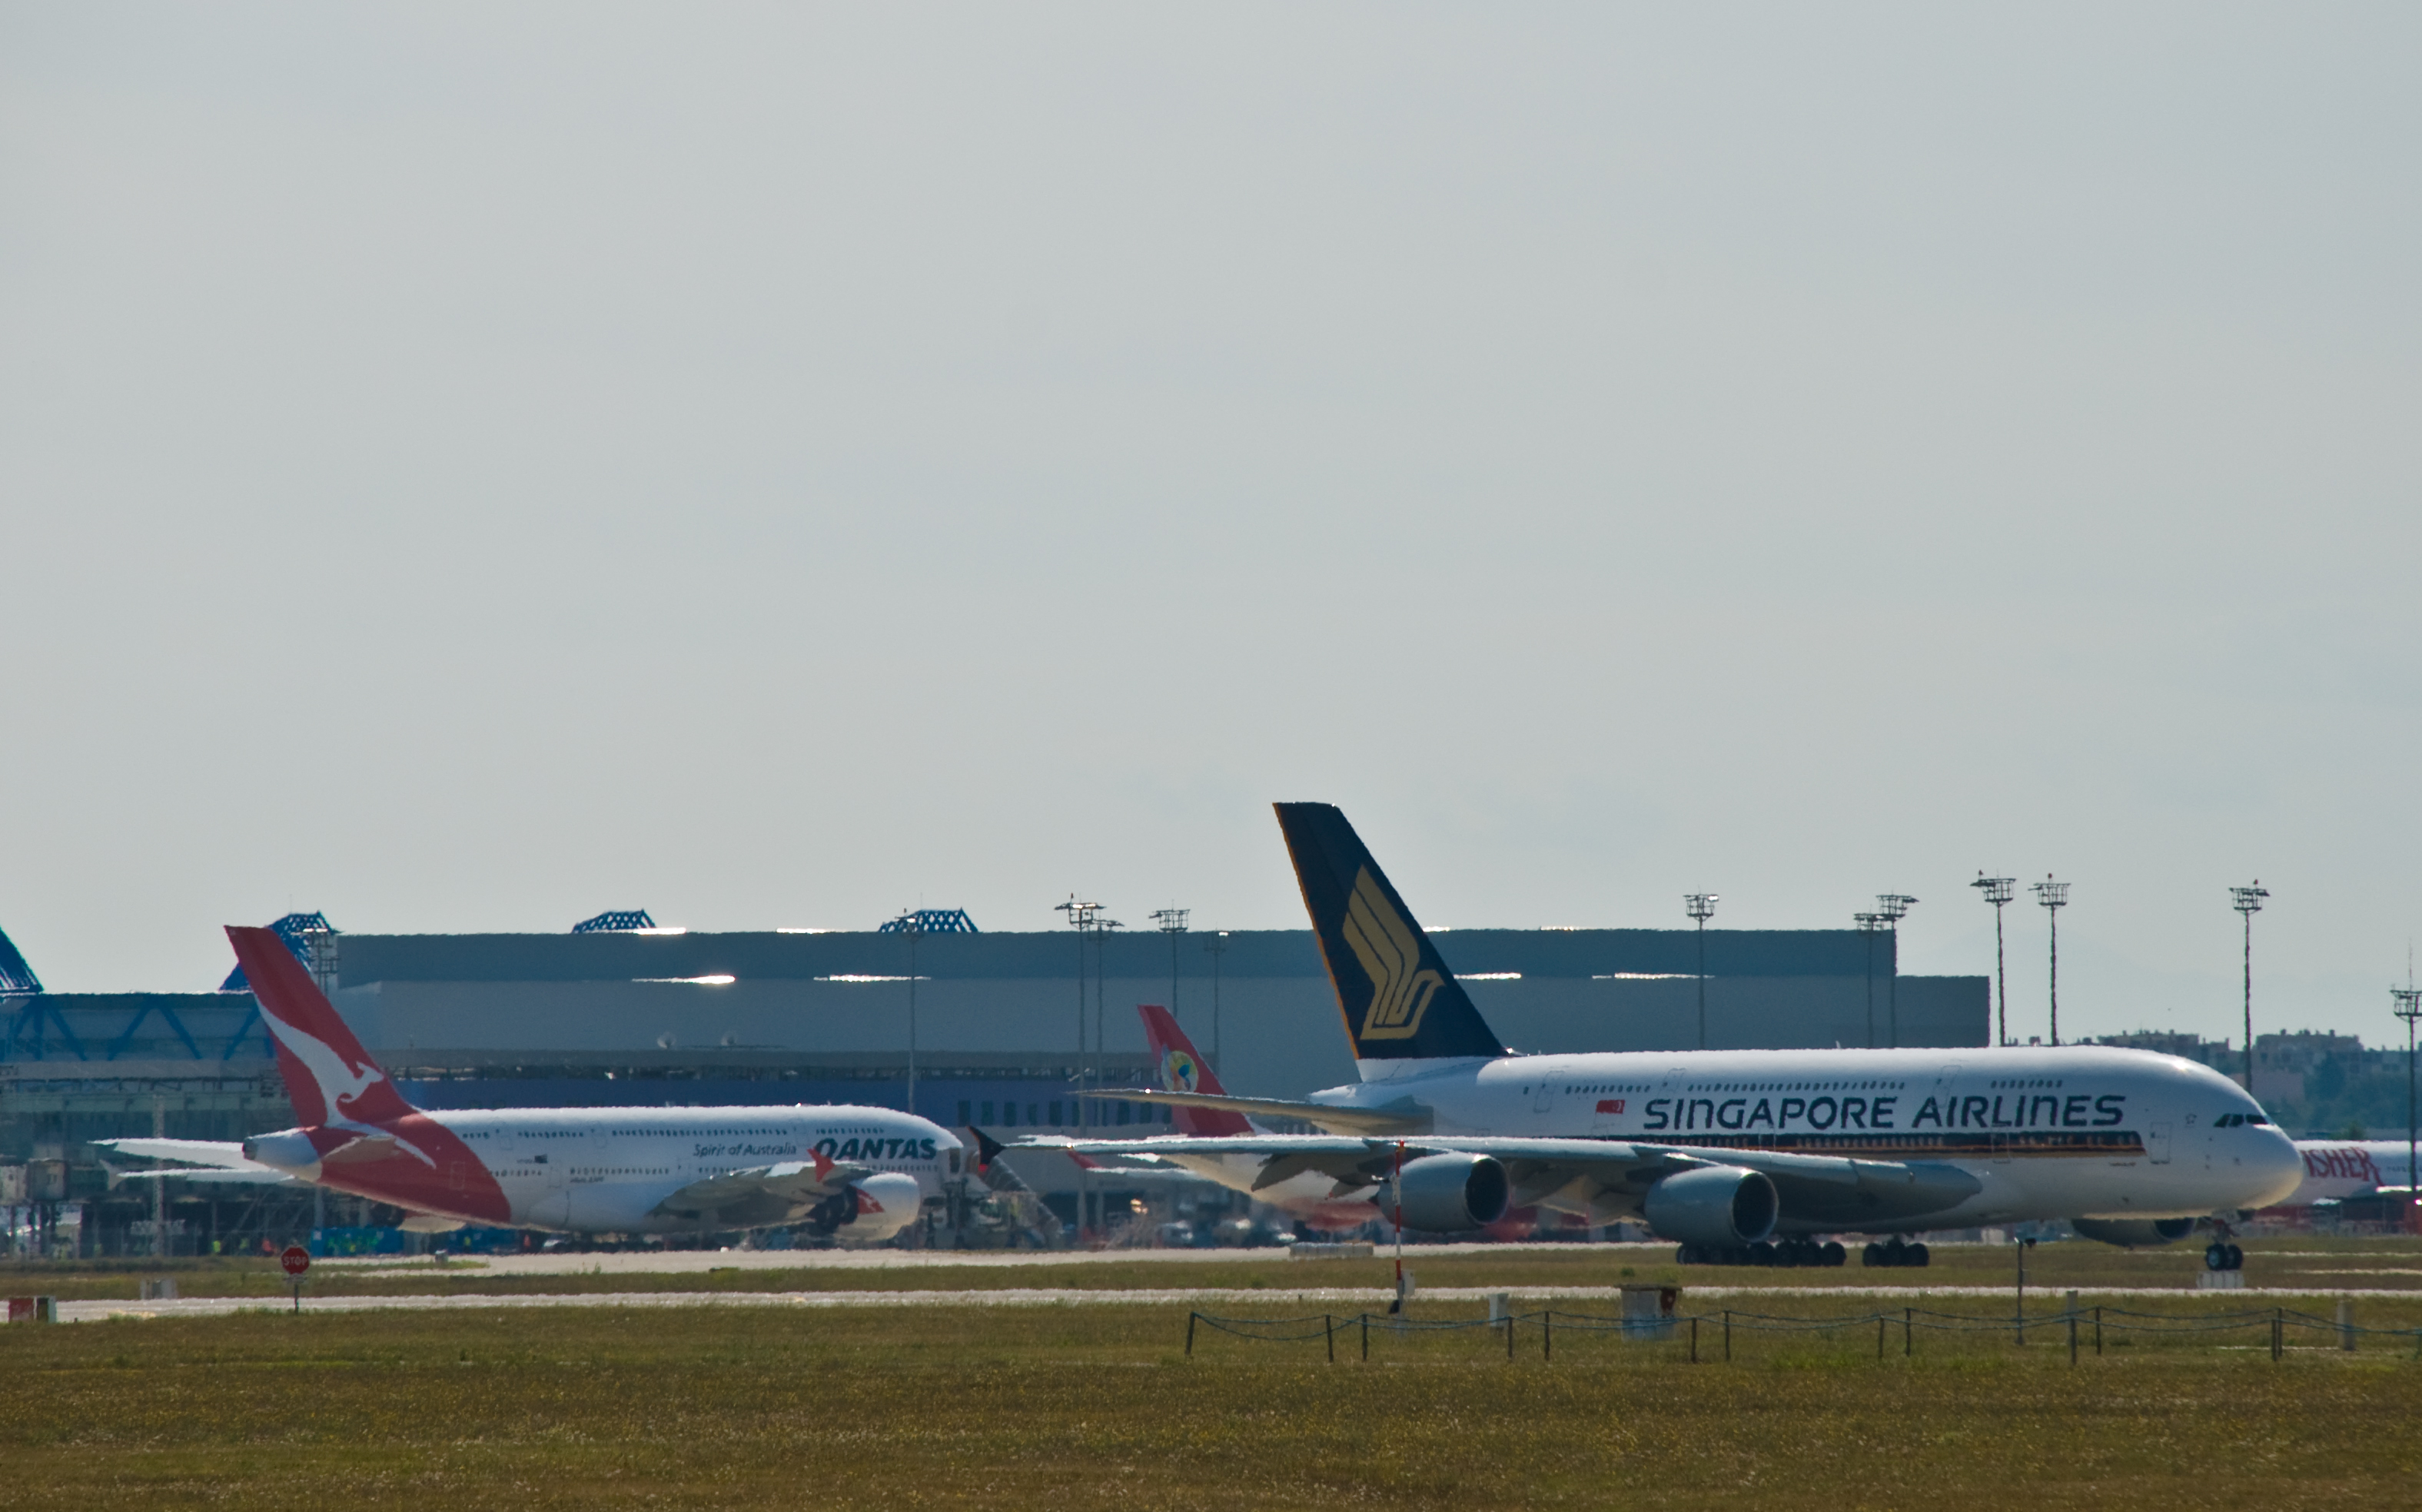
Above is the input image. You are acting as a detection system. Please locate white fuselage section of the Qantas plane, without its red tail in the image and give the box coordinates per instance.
[429,1105,959,1233]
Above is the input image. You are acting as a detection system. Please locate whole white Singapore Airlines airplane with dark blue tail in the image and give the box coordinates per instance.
[1029,805,2304,1268]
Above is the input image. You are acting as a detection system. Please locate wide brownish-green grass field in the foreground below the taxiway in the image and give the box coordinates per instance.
[0,1294,2422,1510]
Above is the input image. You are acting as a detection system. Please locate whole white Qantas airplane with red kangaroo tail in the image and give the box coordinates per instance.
[186,928,962,1245]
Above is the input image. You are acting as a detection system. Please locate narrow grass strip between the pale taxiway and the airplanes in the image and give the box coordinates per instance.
[14,1236,2422,1301]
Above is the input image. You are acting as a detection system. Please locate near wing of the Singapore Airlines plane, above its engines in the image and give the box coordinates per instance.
[1027,1134,1978,1226]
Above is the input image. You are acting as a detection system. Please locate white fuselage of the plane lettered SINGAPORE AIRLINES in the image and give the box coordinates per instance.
[1313,1045,2304,1231]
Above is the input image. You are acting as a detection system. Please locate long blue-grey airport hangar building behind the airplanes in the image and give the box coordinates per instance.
[0,911,1991,1158]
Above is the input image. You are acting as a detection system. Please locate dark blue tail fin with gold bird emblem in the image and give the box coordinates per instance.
[1274,805,1507,1081]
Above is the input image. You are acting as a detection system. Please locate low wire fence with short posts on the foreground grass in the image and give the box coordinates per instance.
[1184,1306,2422,1364]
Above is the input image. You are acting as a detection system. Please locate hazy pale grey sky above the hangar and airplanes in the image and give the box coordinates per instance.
[0,5,2422,1042]
